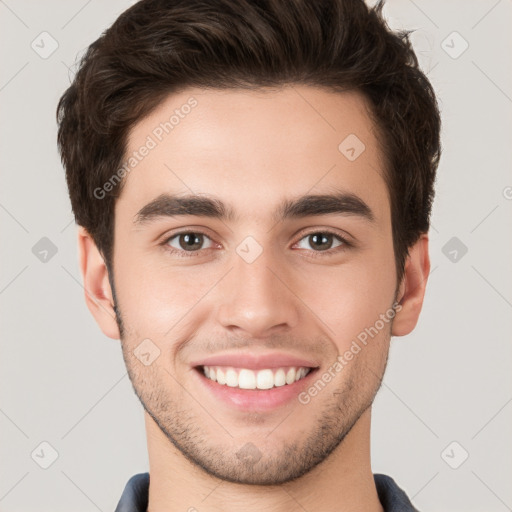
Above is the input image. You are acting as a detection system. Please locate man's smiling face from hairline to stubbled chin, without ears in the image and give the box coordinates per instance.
[108,86,400,484]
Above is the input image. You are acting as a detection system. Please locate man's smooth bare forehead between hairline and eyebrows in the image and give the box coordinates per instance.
[116,85,389,224]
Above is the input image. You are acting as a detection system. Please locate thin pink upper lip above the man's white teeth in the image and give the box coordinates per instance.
[192,352,318,370]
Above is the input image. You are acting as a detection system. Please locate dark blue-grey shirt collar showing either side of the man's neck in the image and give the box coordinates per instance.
[115,473,419,512]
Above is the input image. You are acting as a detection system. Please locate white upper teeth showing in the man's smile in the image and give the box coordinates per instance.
[203,366,311,389]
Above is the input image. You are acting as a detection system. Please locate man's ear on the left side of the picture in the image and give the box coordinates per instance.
[78,226,120,340]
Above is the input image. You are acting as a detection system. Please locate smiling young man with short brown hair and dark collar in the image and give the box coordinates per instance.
[58,0,440,512]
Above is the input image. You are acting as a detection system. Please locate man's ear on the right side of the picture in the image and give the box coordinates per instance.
[391,234,430,336]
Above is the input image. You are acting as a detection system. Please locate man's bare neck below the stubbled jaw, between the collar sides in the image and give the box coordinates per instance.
[144,408,383,512]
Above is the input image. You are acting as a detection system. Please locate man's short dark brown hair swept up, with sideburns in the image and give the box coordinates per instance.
[57,0,441,280]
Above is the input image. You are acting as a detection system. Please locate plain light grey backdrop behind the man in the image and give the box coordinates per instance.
[0,0,512,512]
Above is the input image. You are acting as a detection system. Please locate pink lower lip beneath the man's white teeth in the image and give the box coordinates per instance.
[195,368,318,412]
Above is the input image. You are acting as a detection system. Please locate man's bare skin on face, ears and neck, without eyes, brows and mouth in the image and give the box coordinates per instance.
[78,86,430,512]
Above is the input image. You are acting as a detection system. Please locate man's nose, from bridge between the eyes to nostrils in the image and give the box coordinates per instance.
[217,245,300,338]
